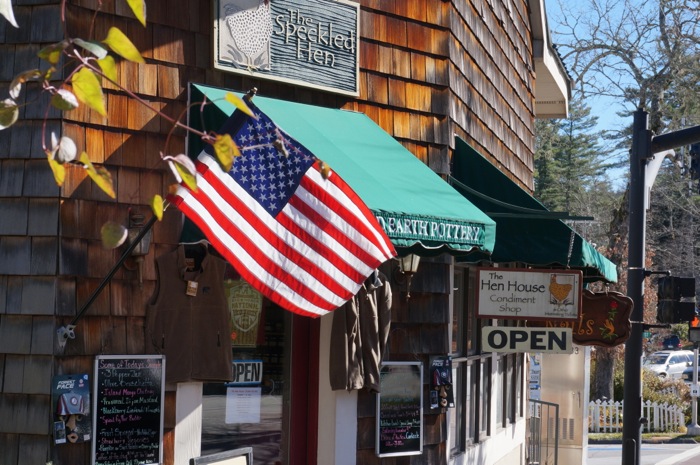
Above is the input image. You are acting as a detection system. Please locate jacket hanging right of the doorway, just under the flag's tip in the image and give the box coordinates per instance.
[328,271,392,392]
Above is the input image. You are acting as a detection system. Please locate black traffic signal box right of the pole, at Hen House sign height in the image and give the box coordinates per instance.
[656,276,697,324]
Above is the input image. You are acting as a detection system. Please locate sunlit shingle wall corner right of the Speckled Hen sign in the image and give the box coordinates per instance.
[347,0,534,188]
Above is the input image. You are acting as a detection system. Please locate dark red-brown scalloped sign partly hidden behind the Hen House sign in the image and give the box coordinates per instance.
[527,289,636,347]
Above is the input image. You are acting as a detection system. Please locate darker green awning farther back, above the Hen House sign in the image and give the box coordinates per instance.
[451,138,617,282]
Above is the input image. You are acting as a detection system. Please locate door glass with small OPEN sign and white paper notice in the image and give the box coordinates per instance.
[202,302,291,465]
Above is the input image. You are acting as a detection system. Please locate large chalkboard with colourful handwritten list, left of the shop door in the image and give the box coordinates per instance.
[92,355,165,465]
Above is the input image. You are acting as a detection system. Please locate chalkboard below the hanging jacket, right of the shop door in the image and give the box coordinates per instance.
[376,362,423,457]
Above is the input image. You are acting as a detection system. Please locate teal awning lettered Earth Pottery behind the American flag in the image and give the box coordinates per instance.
[188,84,496,255]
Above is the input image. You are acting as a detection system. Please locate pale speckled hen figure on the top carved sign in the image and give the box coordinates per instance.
[221,0,272,70]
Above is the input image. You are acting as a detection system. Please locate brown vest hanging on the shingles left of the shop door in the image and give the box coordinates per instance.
[146,245,233,383]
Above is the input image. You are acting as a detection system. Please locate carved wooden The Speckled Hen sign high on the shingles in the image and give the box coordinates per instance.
[213,0,360,96]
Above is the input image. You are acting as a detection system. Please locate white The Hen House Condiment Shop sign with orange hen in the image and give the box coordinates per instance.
[476,268,583,321]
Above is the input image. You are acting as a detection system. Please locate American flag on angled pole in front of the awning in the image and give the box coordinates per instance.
[170,102,396,317]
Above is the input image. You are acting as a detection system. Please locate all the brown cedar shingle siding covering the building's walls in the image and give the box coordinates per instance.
[0,0,534,465]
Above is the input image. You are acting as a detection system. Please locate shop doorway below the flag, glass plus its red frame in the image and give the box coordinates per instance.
[202,300,319,465]
